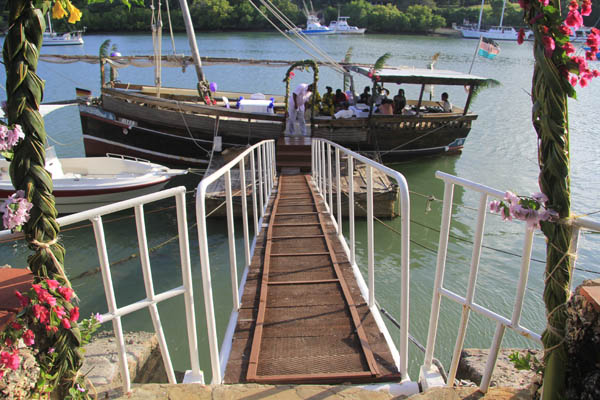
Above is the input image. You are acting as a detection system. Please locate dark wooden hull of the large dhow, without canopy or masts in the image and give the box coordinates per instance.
[79,87,477,167]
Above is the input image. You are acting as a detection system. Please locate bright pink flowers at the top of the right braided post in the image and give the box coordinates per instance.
[517,0,600,87]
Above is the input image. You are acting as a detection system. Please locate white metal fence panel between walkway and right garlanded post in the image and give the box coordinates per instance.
[419,171,600,393]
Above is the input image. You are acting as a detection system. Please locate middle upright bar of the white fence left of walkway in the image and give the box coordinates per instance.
[135,204,177,384]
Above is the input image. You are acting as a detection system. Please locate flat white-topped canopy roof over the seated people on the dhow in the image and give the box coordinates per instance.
[346,65,487,86]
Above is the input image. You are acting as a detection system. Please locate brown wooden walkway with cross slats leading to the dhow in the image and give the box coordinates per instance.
[225,175,400,383]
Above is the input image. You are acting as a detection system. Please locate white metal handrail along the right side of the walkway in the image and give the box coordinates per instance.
[312,139,410,376]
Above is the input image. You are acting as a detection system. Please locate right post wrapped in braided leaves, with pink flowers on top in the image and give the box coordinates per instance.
[518,0,600,399]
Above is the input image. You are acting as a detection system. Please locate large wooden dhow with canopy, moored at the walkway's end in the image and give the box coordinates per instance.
[79,60,486,166]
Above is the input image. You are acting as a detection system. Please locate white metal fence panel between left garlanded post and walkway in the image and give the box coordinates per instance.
[0,186,204,393]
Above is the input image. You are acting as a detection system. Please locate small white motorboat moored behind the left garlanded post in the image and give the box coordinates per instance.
[0,149,187,214]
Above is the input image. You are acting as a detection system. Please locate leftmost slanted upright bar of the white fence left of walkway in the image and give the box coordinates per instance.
[92,217,131,393]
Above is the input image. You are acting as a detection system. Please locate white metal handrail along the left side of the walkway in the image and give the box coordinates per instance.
[196,140,276,384]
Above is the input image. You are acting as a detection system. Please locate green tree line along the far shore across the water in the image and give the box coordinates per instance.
[0,0,600,33]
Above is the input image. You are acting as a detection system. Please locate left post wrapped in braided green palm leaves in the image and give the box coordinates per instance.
[3,0,82,396]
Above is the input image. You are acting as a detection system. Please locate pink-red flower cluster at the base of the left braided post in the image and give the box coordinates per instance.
[0,279,102,398]
